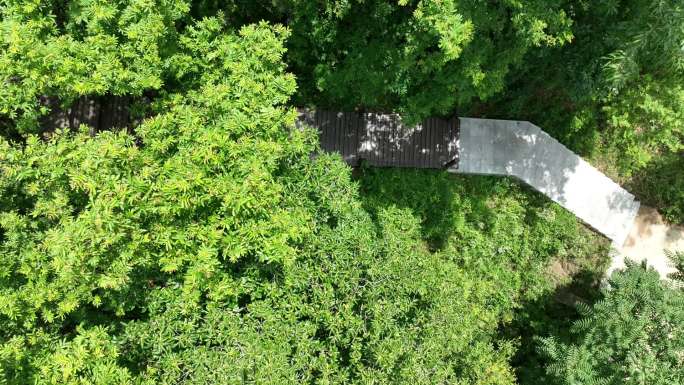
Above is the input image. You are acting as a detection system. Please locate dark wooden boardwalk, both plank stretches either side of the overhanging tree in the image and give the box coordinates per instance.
[36,100,459,168]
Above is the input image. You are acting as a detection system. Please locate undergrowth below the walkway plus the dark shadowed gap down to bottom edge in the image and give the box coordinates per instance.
[360,169,608,384]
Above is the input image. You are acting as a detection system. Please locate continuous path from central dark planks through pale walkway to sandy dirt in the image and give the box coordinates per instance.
[298,109,684,278]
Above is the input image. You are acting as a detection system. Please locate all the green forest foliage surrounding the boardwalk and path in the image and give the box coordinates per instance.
[0,0,684,385]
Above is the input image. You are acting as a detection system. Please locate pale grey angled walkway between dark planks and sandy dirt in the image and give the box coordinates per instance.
[449,118,639,248]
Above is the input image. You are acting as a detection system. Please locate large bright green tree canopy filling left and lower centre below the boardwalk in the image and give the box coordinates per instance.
[0,8,588,384]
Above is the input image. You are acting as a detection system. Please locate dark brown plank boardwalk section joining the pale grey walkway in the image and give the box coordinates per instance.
[297,109,459,168]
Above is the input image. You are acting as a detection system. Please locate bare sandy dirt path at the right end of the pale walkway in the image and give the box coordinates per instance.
[608,205,684,277]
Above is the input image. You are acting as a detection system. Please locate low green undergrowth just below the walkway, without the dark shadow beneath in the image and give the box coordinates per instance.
[361,169,606,309]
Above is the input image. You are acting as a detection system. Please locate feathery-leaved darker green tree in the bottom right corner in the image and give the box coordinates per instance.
[541,265,684,385]
